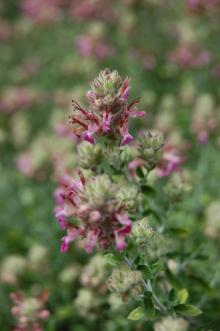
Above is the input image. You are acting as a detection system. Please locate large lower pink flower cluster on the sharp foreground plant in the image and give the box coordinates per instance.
[55,172,131,252]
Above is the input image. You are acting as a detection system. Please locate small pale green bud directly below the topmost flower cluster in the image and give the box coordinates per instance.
[78,141,103,169]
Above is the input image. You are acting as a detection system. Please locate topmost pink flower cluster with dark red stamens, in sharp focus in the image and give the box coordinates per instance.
[70,69,145,145]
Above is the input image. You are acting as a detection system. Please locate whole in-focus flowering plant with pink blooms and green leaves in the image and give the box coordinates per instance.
[55,69,205,330]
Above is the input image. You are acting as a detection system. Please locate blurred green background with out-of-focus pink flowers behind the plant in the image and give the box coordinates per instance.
[0,0,220,331]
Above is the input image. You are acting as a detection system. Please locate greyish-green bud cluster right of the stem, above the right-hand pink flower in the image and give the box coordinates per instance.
[139,132,164,170]
